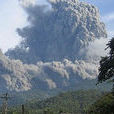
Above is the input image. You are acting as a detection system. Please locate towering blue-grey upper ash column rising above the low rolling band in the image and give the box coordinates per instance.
[7,0,107,64]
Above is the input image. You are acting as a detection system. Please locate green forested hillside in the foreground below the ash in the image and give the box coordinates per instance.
[3,90,105,114]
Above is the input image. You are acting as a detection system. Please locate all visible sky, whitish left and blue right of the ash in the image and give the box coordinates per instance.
[0,0,114,52]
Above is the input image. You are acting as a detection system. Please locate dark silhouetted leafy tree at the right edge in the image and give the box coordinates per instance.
[98,38,114,89]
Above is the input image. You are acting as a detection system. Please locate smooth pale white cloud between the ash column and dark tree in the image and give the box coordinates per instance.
[80,38,109,61]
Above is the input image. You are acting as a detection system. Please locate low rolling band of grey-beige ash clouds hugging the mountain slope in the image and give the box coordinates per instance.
[0,52,98,92]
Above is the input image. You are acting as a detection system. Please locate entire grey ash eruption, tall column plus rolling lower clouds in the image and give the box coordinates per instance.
[0,0,107,91]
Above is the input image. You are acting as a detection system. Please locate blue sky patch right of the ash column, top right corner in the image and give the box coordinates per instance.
[81,0,114,37]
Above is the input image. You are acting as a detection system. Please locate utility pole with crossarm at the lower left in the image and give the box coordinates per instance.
[0,93,10,114]
